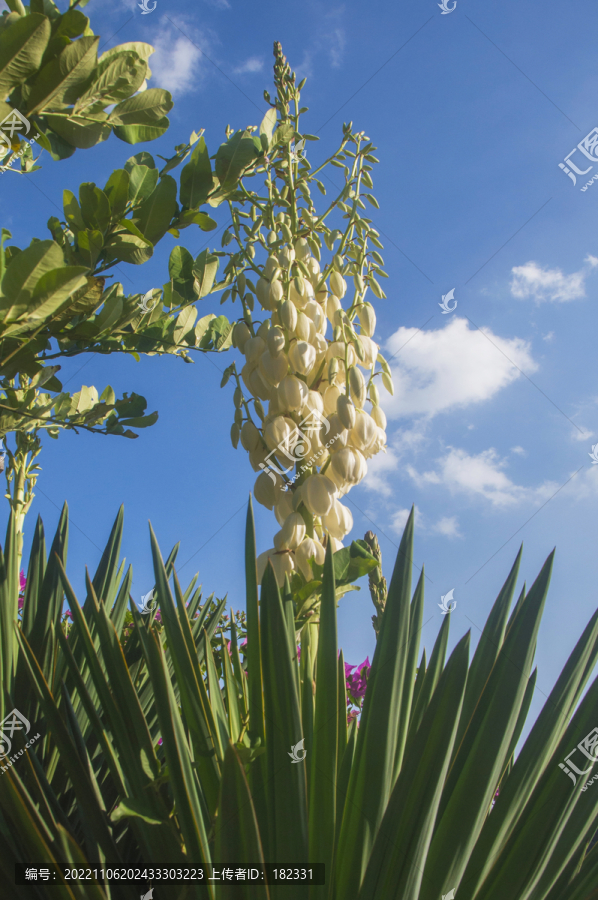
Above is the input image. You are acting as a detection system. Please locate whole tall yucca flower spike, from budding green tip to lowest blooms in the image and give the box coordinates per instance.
[223,51,393,586]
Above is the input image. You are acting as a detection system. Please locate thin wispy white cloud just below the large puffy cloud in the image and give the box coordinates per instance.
[406,447,558,508]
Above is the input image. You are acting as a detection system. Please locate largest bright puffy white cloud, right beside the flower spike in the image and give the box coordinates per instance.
[382,318,538,418]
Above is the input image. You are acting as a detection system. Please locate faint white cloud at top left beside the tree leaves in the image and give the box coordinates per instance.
[150,19,208,97]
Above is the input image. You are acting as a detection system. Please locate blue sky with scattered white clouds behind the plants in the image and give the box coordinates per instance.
[0,0,598,715]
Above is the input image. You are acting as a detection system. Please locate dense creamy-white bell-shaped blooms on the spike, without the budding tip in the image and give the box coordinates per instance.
[232,229,390,556]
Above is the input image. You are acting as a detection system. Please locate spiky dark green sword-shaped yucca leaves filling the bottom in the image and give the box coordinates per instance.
[0,506,598,900]
